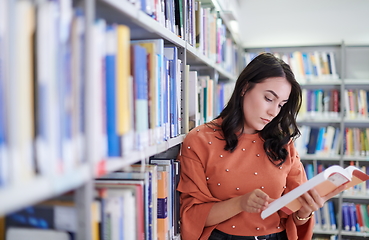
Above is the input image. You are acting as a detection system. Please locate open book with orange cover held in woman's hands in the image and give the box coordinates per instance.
[261,165,369,219]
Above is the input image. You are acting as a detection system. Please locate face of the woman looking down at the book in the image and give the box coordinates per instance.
[243,77,291,134]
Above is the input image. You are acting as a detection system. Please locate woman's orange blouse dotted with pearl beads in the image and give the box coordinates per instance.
[177,119,314,240]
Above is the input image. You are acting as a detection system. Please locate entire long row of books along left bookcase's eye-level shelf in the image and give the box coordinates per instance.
[0,0,239,187]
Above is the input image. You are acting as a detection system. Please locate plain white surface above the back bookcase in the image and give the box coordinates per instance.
[235,0,369,48]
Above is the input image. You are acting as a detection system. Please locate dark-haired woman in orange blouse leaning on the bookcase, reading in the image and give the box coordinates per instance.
[178,53,342,240]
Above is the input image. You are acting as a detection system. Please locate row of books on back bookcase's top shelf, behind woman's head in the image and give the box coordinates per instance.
[245,50,339,83]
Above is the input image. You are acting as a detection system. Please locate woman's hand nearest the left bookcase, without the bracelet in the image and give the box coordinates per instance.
[240,189,273,213]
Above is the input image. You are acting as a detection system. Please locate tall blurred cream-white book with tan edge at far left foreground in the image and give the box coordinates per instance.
[8,0,36,182]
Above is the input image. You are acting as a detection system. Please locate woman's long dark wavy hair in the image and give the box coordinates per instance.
[213,53,301,166]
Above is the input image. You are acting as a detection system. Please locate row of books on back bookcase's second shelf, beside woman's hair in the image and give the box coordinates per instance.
[298,88,341,120]
